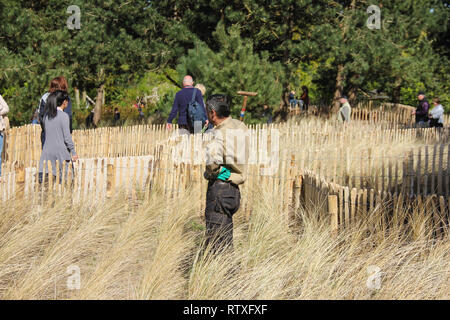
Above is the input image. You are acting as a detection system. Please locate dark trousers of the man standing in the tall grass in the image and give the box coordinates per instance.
[205,180,241,253]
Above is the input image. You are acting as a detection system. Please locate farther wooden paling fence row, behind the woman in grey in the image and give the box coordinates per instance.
[2,119,450,166]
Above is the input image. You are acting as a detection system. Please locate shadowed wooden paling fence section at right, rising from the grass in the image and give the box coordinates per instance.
[295,171,450,236]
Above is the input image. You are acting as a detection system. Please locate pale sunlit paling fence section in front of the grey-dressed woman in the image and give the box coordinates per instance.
[0,156,154,202]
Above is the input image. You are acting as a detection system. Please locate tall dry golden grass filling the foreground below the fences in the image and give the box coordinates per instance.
[0,188,450,299]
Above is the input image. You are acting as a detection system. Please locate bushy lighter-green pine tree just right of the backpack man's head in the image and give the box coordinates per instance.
[177,24,283,123]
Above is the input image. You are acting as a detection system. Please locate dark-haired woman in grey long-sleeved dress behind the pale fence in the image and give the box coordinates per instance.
[39,90,78,182]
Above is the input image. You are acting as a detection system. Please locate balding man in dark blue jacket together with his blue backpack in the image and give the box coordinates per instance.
[167,75,208,133]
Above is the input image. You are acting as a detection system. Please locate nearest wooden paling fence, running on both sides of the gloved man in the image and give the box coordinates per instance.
[0,153,450,235]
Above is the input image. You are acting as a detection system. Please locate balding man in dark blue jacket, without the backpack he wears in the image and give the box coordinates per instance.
[167,75,208,133]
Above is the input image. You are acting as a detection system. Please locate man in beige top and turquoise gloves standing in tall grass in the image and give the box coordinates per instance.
[204,95,250,252]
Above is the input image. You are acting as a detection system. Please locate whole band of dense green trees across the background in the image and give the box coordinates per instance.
[0,0,450,127]
